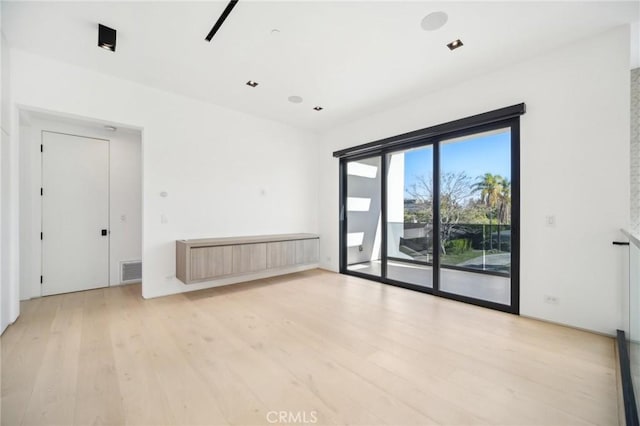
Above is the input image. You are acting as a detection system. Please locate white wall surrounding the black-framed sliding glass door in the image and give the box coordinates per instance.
[319,27,629,334]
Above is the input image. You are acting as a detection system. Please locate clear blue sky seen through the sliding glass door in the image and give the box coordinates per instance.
[404,130,511,194]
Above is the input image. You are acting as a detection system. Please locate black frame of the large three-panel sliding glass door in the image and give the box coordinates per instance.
[333,103,526,315]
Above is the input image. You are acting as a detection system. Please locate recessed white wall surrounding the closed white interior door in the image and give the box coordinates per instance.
[20,116,142,300]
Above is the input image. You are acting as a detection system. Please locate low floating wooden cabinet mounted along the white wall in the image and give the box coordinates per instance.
[176,234,320,284]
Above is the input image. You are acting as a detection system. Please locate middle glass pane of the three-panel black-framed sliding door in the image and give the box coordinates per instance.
[386,146,433,287]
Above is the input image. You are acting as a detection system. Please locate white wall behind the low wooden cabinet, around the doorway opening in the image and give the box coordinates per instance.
[11,49,318,297]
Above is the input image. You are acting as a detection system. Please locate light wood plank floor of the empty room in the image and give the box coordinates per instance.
[1,271,618,425]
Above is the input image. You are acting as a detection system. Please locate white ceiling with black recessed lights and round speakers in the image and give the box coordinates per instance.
[2,0,640,131]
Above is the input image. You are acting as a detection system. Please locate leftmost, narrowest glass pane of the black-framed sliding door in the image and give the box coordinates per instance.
[346,157,382,276]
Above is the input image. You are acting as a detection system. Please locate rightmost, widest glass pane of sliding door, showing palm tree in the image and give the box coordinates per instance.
[439,129,511,305]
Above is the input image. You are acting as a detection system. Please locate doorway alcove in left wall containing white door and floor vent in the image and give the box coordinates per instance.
[19,109,142,300]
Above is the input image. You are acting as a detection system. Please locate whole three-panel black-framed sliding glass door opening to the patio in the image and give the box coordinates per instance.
[334,104,524,313]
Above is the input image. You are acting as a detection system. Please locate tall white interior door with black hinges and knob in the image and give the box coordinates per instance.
[42,132,109,296]
